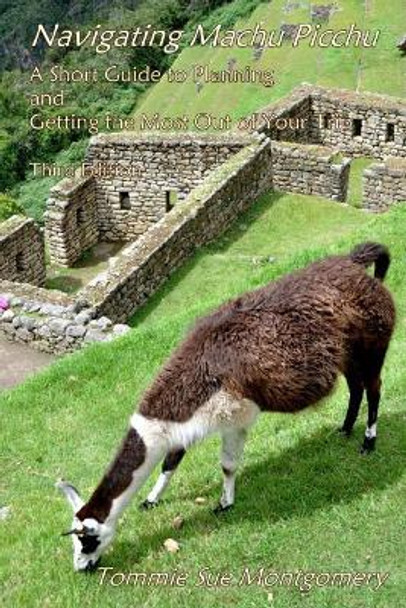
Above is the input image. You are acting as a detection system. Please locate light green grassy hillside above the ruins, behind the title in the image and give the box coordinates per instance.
[136,0,406,119]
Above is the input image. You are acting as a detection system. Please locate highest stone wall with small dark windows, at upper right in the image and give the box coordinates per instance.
[311,87,406,159]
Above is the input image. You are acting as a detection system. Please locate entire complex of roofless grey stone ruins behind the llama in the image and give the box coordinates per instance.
[0,85,406,353]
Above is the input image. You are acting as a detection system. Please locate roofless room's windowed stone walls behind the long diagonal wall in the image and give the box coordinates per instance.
[45,134,247,267]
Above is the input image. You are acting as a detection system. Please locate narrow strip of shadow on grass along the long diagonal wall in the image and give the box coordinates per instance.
[128,192,283,327]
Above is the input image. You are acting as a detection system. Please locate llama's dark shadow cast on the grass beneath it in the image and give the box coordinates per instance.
[110,414,406,571]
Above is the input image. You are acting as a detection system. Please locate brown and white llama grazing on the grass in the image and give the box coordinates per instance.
[57,243,395,571]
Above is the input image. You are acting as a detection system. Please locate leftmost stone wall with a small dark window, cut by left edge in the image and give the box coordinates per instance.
[0,216,45,285]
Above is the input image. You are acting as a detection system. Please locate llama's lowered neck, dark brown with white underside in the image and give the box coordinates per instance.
[77,428,163,525]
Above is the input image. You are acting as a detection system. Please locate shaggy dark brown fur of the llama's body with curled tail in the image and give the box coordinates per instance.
[139,244,395,422]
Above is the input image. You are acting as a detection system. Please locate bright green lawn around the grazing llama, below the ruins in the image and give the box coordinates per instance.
[0,194,406,608]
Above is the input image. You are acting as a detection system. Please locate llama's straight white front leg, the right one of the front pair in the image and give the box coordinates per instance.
[214,429,247,514]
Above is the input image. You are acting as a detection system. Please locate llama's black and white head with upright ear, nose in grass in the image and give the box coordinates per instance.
[56,481,114,572]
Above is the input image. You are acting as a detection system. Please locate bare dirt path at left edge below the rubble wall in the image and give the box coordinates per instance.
[0,338,56,391]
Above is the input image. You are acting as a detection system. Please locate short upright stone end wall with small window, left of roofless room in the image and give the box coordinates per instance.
[44,177,99,266]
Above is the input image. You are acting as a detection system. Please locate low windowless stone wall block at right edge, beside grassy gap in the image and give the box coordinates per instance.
[363,159,406,211]
